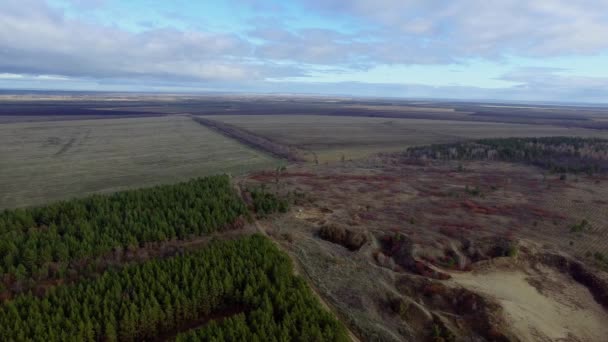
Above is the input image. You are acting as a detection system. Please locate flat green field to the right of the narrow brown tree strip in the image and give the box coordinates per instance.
[205,115,608,161]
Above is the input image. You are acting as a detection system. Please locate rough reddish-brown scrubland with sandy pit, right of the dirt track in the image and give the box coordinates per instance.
[242,156,608,341]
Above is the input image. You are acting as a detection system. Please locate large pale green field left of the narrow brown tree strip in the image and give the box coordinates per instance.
[0,116,281,208]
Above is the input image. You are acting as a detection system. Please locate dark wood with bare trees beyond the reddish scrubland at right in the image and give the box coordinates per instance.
[405,137,608,174]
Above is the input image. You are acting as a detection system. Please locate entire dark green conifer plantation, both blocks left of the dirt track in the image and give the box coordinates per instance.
[0,176,348,341]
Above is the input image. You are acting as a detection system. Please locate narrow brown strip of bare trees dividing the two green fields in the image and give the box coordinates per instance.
[192,116,306,162]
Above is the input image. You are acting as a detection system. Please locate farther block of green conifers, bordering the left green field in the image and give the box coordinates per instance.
[0,176,247,293]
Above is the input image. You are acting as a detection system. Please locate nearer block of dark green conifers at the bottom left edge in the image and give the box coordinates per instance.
[0,235,348,342]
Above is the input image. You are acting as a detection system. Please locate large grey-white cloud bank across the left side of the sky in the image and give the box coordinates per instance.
[0,0,294,81]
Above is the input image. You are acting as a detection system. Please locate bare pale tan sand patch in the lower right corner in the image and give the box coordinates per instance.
[452,268,608,342]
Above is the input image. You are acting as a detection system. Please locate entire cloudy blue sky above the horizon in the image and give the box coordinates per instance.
[0,0,608,103]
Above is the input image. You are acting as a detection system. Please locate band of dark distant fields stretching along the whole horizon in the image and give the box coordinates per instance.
[0,91,608,129]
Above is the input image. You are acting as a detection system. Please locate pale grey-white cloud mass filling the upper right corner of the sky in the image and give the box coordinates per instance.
[300,0,608,58]
